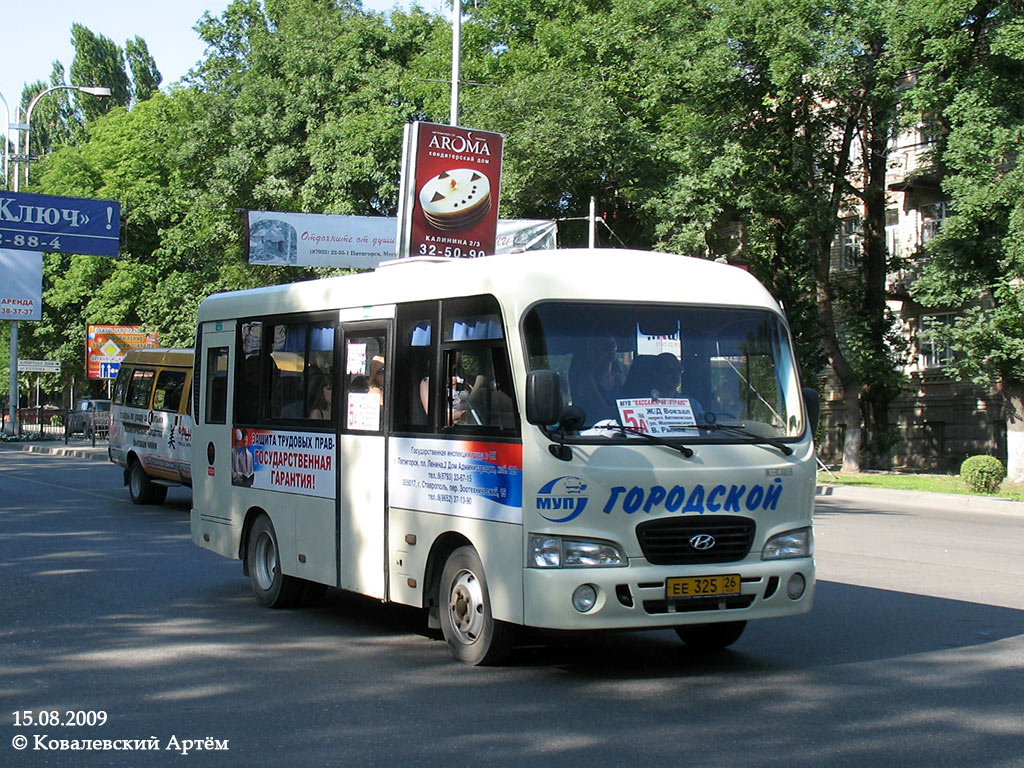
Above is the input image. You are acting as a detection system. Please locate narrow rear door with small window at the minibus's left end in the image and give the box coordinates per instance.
[191,321,236,553]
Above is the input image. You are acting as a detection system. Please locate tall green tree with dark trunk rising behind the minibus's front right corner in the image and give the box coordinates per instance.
[634,0,906,471]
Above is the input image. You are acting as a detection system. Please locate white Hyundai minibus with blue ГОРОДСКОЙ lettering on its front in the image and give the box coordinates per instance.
[191,249,817,664]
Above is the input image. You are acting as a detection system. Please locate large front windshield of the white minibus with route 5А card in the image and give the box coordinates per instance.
[523,302,804,441]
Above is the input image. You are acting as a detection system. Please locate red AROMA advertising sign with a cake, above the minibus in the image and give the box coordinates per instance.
[396,123,504,258]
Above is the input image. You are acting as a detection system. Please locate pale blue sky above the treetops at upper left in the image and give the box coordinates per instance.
[0,0,438,141]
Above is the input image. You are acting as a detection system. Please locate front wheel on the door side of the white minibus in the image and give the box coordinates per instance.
[438,546,514,665]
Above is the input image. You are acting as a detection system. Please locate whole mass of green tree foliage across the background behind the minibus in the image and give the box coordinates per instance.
[9,0,1024,453]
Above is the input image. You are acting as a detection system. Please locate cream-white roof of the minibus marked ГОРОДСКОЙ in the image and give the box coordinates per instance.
[193,249,779,322]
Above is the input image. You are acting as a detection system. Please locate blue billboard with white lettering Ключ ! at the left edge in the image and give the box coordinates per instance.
[0,191,121,256]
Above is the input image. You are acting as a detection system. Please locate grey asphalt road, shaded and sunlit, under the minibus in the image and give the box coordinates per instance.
[0,450,1024,768]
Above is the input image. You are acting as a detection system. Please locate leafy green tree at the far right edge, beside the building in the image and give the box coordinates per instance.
[913,6,1024,482]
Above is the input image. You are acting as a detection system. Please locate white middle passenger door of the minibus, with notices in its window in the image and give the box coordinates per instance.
[337,321,393,599]
